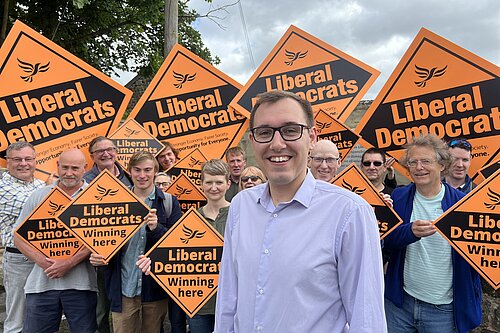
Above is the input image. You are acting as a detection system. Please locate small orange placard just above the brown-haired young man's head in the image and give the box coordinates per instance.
[108,118,165,170]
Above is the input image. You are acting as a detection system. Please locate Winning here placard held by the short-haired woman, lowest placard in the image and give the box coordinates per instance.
[146,208,224,318]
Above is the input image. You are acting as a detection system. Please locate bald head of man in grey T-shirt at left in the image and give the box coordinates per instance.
[57,148,87,194]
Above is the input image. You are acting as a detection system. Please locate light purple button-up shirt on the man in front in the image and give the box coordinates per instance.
[215,172,387,333]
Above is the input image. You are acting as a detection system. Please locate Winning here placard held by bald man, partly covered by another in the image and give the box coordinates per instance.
[15,186,83,259]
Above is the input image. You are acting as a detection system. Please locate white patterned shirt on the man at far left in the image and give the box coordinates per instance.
[0,172,45,247]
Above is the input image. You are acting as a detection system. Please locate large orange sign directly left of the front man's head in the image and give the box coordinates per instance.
[129,44,248,159]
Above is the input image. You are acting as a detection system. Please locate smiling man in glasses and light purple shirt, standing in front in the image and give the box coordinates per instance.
[215,91,386,333]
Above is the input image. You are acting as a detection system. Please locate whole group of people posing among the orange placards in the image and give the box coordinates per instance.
[0,91,481,333]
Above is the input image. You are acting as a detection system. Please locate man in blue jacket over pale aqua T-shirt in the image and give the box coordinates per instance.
[384,135,481,333]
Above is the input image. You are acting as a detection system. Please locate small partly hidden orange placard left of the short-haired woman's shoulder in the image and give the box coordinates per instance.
[167,172,207,212]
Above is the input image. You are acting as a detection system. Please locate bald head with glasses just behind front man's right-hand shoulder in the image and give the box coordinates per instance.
[309,140,340,182]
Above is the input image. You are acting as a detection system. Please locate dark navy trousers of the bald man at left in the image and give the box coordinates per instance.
[23,289,97,333]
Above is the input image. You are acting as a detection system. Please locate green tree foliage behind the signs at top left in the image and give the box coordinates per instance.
[2,0,220,75]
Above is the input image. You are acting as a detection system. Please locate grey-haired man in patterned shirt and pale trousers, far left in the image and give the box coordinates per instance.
[0,141,45,333]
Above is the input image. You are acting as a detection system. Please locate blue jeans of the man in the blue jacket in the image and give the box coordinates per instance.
[385,292,456,333]
